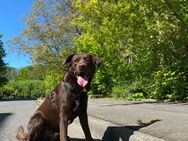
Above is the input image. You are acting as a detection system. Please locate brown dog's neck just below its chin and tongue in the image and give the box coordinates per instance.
[63,72,90,91]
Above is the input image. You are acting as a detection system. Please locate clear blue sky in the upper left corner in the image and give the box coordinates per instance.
[0,0,34,68]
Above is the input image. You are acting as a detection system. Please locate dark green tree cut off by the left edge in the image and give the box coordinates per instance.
[0,35,7,86]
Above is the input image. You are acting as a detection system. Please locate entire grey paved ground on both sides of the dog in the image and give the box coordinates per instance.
[0,99,188,141]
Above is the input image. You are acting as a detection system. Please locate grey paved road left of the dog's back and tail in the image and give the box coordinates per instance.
[0,100,36,141]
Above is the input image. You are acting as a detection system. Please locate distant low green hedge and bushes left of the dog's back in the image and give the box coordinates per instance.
[0,66,60,99]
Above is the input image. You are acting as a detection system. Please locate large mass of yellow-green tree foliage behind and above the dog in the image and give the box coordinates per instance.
[7,0,188,100]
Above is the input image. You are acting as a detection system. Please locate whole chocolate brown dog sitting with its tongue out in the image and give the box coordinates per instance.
[16,54,101,141]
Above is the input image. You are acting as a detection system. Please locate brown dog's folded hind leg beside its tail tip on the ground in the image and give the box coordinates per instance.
[28,111,44,141]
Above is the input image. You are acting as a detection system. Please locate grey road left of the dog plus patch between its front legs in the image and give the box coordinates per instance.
[0,100,100,141]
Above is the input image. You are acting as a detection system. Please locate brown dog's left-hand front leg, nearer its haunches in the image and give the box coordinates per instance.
[59,106,68,141]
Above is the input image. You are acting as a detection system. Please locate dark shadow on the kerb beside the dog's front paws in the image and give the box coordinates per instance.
[70,126,144,141]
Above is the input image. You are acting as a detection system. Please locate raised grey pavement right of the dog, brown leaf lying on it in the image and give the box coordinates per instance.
[88,99,188,141]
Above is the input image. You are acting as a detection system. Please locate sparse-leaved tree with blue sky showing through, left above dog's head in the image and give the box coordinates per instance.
[10,0,76,73]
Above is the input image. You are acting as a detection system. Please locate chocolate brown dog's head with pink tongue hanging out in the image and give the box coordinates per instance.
[65,54,102,87]
